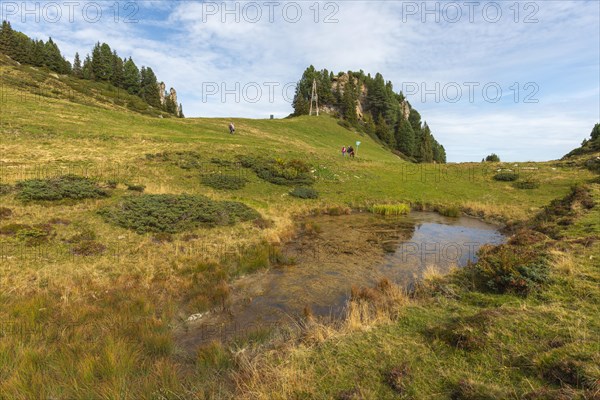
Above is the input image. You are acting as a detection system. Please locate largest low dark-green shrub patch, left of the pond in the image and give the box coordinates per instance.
[99,194,260,233]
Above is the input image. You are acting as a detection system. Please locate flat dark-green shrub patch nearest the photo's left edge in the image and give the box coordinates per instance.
[17,175,109,202]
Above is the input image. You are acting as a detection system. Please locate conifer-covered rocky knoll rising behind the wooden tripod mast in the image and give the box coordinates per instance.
[293,65,446,163]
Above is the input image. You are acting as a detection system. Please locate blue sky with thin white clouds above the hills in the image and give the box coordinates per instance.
[0,0,600,162]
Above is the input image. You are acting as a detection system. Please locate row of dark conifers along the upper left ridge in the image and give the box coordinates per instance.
[0,21,183,118]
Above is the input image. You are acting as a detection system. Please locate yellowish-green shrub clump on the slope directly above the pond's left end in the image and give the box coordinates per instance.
[240,156,314,186]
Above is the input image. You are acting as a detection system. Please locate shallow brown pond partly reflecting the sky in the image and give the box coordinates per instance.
[178,212,504,348]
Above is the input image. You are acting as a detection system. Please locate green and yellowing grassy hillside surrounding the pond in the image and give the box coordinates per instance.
[0,64,598,399]
